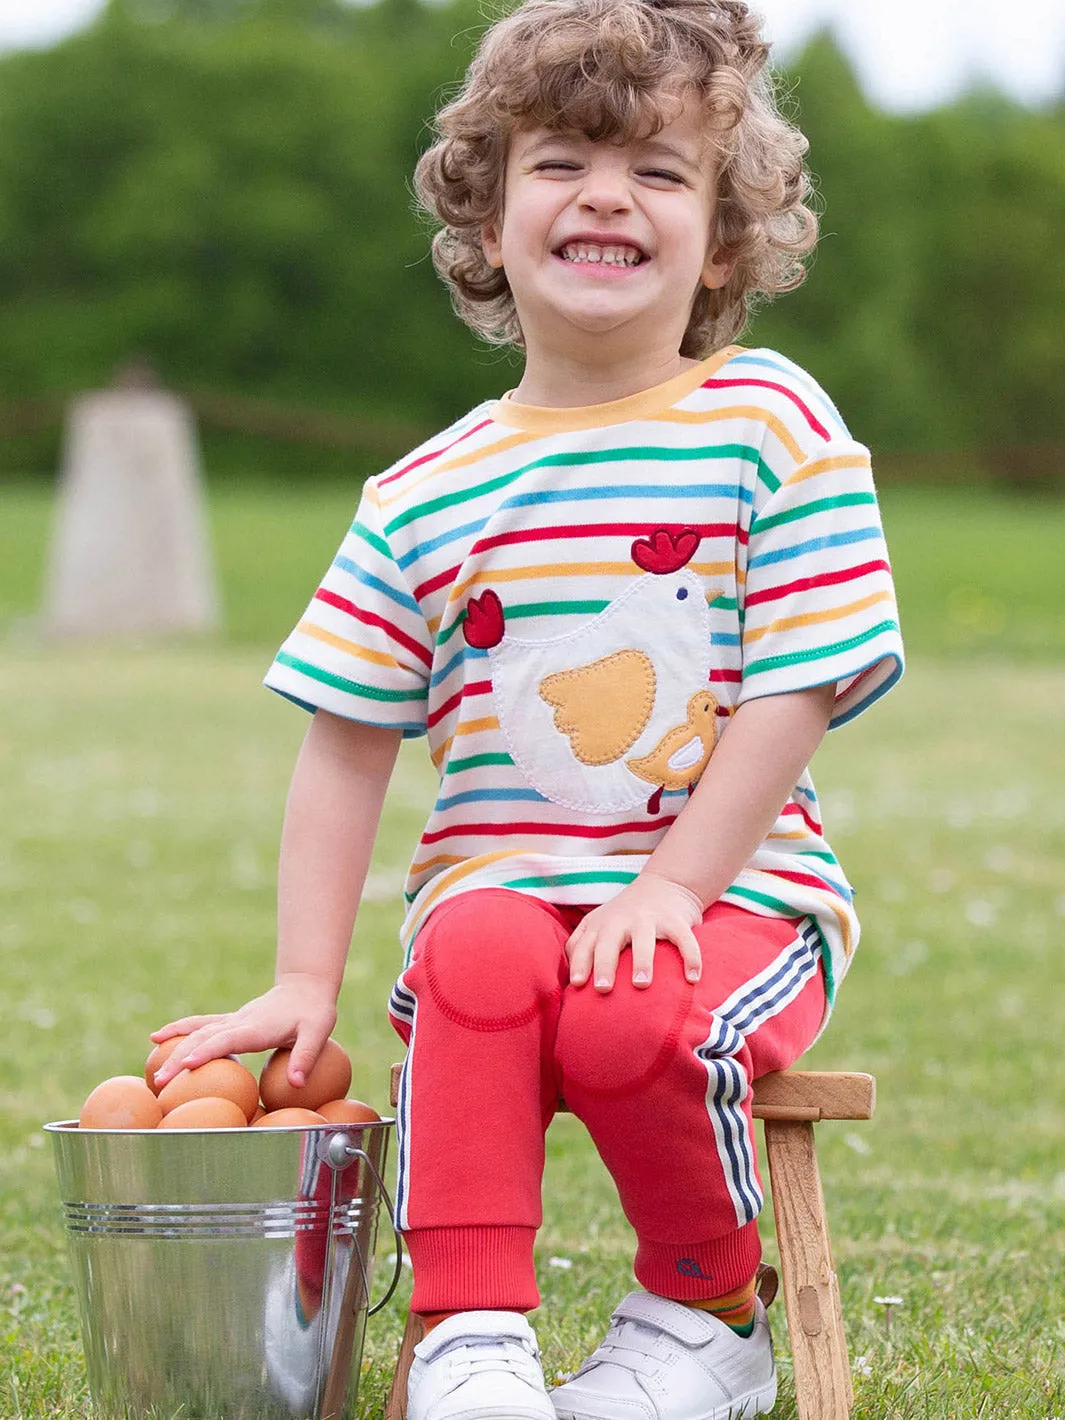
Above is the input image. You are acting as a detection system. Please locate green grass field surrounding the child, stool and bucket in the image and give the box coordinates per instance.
[0,490,1065,1420]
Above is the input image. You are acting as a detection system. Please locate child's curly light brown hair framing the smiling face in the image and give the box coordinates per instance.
[415,0,818,359]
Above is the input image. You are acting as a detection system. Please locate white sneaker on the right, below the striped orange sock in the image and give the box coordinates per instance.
[551,1292,777,1420]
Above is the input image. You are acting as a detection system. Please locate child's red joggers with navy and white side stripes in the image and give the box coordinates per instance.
[389,888,825,1312]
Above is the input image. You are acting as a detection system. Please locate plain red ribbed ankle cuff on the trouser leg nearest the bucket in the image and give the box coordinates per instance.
[403,1227,540,1312]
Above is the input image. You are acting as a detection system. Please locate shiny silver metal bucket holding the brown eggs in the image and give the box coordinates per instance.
[44,1119,400,1420]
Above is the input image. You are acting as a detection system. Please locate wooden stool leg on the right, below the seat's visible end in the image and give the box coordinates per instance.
[765,1119,853,1420]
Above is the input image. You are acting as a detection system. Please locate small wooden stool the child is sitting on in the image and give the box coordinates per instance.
[385,1065,876,1420]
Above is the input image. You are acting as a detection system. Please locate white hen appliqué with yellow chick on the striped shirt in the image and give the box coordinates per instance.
[463,528,724,814]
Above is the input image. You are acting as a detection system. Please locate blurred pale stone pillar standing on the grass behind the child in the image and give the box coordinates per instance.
[41,364,219,636]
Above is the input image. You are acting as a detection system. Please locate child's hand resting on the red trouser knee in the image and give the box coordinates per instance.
[565,869,703,991]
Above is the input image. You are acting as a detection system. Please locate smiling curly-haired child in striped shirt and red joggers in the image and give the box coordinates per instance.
[155,0,902,1420]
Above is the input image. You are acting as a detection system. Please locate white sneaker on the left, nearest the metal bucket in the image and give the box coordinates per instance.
[406,1312,555,1420]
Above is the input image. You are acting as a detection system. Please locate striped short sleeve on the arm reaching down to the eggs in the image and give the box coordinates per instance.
[264,479,433,737]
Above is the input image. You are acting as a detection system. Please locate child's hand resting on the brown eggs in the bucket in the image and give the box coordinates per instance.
[151,971,337,1089]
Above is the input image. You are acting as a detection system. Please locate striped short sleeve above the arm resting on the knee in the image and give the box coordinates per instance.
[740,440,903,726]
